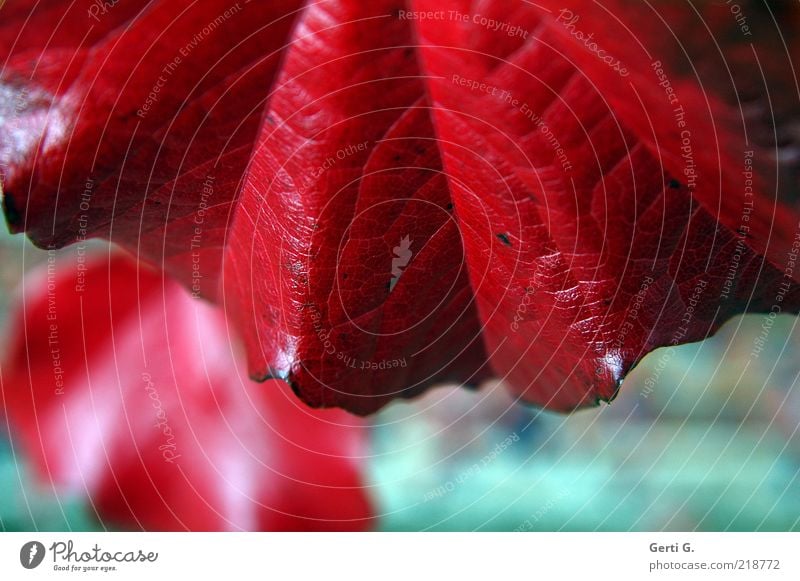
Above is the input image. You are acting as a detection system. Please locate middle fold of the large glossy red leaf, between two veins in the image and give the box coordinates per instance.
[220,0,487,413]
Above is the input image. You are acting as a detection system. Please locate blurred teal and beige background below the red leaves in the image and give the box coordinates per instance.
[0,229,800,531]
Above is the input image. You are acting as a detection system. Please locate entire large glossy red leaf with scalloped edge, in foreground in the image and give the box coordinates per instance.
[0,0,800,413]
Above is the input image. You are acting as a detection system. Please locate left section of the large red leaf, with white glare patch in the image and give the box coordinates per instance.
[0,0,300,296]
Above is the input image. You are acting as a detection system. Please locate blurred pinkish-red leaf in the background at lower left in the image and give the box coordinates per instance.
[1,255,370,530]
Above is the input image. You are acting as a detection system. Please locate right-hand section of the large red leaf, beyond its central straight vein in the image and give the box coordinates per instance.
[412,2,798,410]
